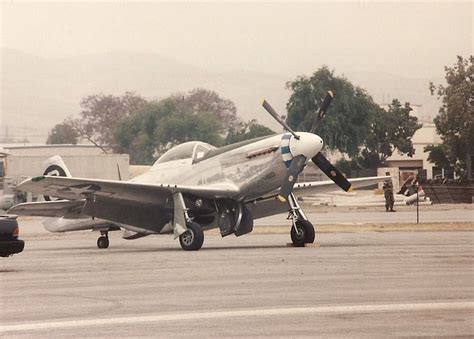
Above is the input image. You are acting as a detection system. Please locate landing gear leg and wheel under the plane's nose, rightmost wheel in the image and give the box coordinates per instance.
[288,193,315,247]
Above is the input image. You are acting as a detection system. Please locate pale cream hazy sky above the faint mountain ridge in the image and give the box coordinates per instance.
[1,1,473,77]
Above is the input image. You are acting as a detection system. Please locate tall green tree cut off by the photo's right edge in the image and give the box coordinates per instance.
[430,55,474,181]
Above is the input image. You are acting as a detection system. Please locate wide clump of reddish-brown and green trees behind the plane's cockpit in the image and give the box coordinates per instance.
[73,88,238,164]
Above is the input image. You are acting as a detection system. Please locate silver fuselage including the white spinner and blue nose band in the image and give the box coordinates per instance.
[132,133,323,201]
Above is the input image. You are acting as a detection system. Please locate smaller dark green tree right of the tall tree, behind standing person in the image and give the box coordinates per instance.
[359,99,422,168]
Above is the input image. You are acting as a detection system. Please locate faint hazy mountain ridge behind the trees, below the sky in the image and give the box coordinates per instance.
[0,49,440,142]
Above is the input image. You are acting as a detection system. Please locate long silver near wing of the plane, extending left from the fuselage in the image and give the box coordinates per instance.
[16,175,239,204]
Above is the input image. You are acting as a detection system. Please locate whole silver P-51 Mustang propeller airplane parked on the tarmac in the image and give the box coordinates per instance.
[9,92,385,250]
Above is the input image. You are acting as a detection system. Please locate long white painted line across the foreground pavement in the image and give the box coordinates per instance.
[0,301,474,333]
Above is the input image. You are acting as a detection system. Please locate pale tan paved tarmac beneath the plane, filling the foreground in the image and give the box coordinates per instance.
[0,232,474,337]
